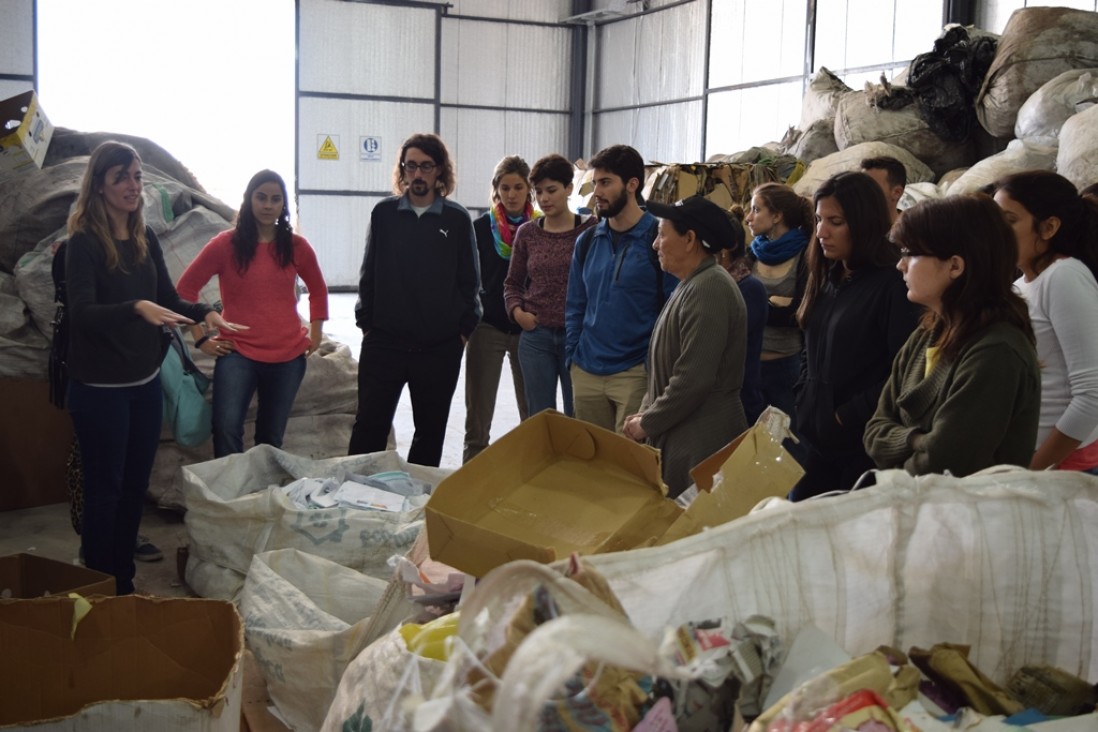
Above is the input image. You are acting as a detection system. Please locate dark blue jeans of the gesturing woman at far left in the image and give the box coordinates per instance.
[68,375,164,595]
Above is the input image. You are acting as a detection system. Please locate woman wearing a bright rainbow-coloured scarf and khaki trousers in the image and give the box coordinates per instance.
[462,155,534,462]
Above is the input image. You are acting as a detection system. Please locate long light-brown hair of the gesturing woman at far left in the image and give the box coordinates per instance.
[68,139,148,271]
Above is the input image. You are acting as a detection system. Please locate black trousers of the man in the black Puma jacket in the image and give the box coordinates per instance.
[347,335,463,468]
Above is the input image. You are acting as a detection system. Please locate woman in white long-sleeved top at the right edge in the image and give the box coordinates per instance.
[995,170,1098,472]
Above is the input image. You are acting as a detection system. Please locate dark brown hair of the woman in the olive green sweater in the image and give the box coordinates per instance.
[892,193,1037,362]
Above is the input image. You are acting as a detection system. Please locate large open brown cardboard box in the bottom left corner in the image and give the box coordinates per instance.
[0,596,244,732]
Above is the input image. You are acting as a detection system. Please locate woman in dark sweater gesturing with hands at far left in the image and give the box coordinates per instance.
[65,142,239,595]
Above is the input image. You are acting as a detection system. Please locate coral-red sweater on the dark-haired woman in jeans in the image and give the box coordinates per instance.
[176,230,328,363]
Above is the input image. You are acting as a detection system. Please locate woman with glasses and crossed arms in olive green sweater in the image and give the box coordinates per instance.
[864,194,1041,475]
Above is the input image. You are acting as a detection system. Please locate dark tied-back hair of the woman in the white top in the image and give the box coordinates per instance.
[995,170,1098,280]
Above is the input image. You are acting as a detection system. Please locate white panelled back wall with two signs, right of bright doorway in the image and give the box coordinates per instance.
[298,0,572,286]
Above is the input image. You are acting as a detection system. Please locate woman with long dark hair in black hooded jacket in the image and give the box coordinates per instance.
[791,172,919,500]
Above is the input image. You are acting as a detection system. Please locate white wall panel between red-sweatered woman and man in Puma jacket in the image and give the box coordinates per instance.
[298,195,381,288]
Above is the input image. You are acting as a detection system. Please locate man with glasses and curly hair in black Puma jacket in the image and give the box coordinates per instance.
[348,134,481,466]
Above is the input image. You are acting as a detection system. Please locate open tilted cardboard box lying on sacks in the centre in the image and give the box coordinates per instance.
[426,409,682,576]
